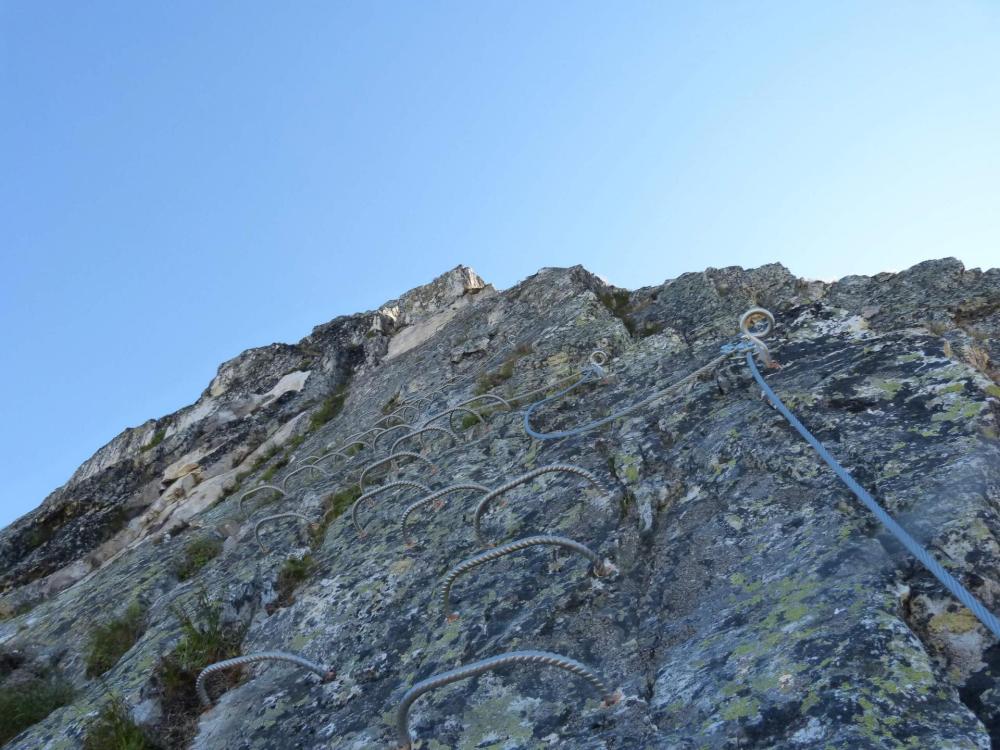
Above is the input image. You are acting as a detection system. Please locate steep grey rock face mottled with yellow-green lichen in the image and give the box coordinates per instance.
[0,260,1000,750]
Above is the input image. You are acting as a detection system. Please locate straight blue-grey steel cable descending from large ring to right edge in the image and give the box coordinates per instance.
[746,328,1000,639]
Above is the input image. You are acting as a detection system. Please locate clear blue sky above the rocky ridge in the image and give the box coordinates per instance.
[0,0,1000,524]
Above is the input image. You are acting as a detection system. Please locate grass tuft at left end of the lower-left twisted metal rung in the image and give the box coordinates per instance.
[157,592,246,747]
